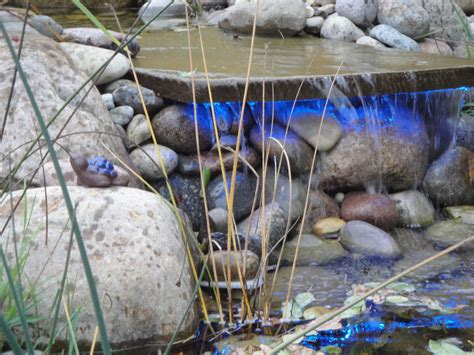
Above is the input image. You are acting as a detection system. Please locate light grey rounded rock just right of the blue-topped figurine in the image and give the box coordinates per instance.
[130,143,178,180]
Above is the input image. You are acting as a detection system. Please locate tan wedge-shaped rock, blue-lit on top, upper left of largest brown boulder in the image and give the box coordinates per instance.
[276,111,343,152]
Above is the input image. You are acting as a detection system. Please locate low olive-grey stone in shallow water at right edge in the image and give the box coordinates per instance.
[426,221,474,251]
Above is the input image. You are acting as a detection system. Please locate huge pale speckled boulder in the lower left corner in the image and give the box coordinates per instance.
[0,186,199,351]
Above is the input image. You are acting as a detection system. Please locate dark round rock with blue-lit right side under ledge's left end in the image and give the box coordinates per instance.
[152,105,214,154]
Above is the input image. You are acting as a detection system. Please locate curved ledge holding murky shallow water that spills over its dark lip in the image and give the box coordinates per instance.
[131,28,474,102]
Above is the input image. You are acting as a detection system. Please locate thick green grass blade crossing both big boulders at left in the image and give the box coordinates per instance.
[0,22,111,355]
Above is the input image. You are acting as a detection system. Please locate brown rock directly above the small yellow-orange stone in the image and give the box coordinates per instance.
[303,190,340,233]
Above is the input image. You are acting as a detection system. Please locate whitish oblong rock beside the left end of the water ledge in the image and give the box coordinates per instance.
[59,42,130,85]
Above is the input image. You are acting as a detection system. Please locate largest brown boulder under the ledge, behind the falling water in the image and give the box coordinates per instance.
[315,110,429,195]
